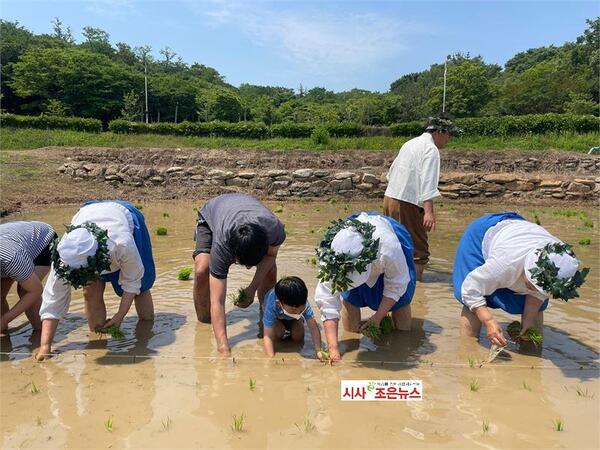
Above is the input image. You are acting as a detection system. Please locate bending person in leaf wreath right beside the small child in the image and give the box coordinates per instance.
[315,212,416,361]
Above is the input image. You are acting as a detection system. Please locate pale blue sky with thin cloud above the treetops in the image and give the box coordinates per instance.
[0,0,600,91]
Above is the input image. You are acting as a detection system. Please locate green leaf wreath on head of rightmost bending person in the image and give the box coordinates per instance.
[529,242,590,301]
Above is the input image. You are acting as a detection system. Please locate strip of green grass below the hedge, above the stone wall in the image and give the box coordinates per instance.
[0,128,600,152]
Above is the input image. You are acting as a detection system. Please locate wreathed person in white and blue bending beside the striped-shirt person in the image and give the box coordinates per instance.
[38,200,156,359]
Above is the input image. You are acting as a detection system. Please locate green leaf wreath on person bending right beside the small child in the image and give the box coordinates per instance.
[316,219,379,293]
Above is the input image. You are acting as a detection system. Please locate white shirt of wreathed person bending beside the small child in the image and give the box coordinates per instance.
[315,213,410,321]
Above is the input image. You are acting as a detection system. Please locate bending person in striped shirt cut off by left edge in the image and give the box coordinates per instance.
[0,221,56,333]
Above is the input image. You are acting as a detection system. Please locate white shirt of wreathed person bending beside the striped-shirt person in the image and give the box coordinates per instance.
[40,202,144,320]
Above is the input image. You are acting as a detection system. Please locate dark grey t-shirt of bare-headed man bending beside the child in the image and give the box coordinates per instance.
[200,193,285,279]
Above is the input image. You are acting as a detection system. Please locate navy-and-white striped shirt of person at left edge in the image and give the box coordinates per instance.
[0,221,55,282]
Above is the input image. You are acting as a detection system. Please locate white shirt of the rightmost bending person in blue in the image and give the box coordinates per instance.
[461,220,560,311]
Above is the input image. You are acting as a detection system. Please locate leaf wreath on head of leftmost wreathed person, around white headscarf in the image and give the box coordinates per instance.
[50,222,110,289]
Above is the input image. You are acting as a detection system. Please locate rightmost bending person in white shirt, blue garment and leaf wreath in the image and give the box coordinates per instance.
[452,212,588,346]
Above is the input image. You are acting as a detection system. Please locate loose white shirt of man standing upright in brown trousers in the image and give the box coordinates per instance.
[385,132,440,206]
